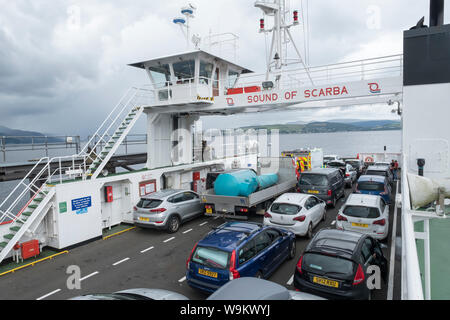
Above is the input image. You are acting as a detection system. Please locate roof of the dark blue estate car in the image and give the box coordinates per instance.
[198,221,265,252]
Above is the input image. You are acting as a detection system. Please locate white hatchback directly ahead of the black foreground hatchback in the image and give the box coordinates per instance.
[336,194,389,240]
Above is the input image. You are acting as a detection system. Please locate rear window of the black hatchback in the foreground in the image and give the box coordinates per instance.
[302,253,353,276]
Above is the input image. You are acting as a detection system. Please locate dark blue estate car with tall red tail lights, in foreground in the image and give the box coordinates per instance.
[186,222,296,293]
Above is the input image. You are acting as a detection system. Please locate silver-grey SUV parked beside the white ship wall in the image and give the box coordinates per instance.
[133,189,204,233]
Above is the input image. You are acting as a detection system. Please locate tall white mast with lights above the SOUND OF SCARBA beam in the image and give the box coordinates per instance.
[255,0,314,87]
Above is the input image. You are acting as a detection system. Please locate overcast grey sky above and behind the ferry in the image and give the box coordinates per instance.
[0,0,450,136]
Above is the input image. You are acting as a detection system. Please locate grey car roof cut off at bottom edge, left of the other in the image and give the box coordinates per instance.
[69,288,189,300]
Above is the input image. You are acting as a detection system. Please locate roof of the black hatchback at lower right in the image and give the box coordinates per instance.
[305,229,365,259]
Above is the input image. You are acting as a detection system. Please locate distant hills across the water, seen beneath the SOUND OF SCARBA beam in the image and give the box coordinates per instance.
[243,120,401,134]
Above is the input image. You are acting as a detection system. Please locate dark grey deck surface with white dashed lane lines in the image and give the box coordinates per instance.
[0,185,400,300]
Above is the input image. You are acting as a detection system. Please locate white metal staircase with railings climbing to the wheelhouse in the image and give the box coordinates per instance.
[0,87,154,263]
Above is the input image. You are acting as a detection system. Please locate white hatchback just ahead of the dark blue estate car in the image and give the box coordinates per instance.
[264,193,326,238]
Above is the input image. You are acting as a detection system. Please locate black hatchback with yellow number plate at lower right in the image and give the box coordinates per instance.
[294,229,387,300]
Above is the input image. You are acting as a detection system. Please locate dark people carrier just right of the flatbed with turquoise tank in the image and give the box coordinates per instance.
[297,168,345,208]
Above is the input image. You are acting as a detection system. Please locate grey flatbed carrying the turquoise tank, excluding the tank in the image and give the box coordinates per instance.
[201,158,297,220]
